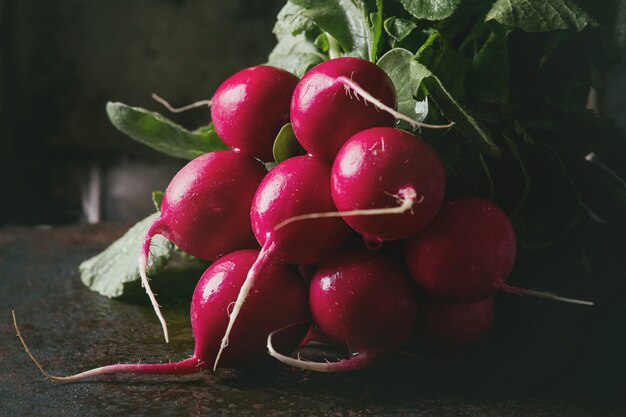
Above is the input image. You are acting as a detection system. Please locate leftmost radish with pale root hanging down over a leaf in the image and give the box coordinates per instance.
[139,151,267,340]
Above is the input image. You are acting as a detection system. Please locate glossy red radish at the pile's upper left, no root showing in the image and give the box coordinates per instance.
[211,65,298,161]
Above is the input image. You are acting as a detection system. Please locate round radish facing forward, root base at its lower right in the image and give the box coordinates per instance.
[331,127,446,245]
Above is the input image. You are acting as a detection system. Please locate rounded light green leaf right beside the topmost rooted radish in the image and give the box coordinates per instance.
[376,48,428,121]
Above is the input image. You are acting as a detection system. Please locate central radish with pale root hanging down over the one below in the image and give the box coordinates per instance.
[216,156,350,366]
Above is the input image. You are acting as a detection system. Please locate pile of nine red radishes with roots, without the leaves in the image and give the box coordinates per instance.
[18,57,588,380]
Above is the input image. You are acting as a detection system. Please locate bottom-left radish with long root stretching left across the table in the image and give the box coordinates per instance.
[14,249,310,381]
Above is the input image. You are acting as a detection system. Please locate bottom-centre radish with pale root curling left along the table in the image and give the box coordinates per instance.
[268,250,417,372]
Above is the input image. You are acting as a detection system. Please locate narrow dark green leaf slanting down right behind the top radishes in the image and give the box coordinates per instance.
[411,60,500,156]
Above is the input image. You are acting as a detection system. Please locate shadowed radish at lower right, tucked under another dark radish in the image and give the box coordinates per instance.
[415,297,494,352]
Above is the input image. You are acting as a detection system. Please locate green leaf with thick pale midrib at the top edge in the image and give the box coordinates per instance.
[292,0,372,60]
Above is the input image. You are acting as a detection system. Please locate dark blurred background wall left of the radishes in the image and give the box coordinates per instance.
[0,0,284,225]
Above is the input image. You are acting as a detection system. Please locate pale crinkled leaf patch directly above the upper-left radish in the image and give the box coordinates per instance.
[267,32,328,78]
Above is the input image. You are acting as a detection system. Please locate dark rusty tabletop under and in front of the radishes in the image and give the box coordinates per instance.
[0,225,626,417]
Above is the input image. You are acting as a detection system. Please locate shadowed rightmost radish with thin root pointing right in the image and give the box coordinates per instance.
[404,197,593,305]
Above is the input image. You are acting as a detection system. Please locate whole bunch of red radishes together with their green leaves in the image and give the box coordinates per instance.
[17,0,623,380]
